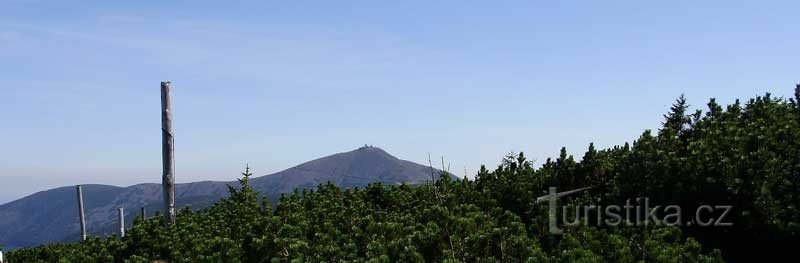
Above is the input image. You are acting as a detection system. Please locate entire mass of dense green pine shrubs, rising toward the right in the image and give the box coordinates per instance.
[8,87,800,262]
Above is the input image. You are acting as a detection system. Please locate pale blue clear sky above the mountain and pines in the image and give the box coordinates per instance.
[0,0,800,203]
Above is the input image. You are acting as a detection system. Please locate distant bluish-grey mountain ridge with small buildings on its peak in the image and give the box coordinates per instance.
[0,146,446,249]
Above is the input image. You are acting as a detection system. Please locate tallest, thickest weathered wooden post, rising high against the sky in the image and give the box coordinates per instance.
[161,81,175,225]
